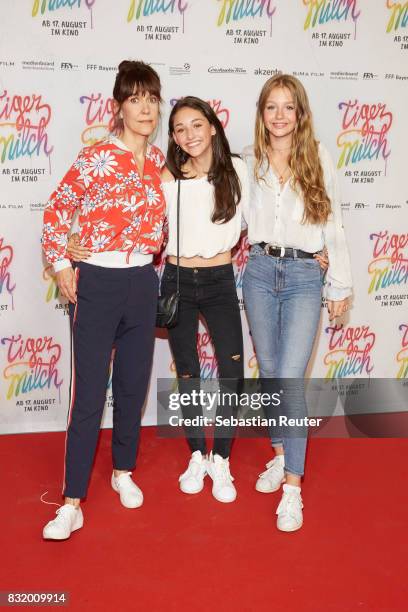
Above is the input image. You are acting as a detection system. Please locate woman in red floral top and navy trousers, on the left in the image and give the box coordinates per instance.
[43,61,165,540]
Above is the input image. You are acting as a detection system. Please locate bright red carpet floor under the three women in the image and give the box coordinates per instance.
[0,428,408,612]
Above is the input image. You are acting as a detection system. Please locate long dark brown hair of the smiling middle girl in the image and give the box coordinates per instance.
[166,96,241,223]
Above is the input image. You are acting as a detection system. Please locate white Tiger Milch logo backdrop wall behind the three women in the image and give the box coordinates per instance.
[0,0,408,433]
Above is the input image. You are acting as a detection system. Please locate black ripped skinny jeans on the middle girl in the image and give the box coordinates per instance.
[161,263,244,458]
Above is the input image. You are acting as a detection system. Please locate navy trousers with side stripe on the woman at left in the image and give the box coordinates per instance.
[63,262,158,498]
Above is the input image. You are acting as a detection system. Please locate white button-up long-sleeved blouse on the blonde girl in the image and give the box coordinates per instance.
[243,144,352,300]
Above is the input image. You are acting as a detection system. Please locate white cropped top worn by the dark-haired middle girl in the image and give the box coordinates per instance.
[162,157,249,259]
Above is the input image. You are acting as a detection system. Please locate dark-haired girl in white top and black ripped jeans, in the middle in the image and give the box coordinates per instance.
[161,96,248,502]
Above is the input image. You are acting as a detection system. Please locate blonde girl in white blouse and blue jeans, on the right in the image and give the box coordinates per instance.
[243,75,352,531]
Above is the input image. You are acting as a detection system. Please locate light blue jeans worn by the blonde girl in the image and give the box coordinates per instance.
[243,245,323,476]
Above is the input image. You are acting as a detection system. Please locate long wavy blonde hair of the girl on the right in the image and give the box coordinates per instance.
[254,74,331,224]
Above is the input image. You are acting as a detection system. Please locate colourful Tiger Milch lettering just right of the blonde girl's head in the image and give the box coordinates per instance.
[337,99,393,172]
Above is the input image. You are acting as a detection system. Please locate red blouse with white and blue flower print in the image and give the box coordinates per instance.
[42,136,166,271]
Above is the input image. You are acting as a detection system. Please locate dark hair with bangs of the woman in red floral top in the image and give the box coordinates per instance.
[109,60,162,134]
